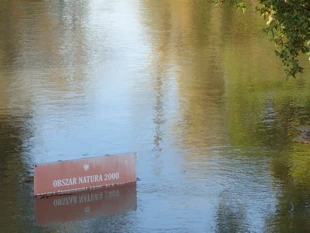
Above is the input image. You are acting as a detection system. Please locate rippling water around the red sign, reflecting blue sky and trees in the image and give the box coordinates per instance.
[0,0,310,233]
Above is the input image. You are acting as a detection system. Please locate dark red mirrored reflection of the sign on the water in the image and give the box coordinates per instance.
[35,183,137,225]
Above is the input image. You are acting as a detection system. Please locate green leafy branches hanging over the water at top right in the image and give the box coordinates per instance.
[215,0,310,77]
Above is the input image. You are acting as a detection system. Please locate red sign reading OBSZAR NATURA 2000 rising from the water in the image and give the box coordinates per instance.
[34,153,137,196]
